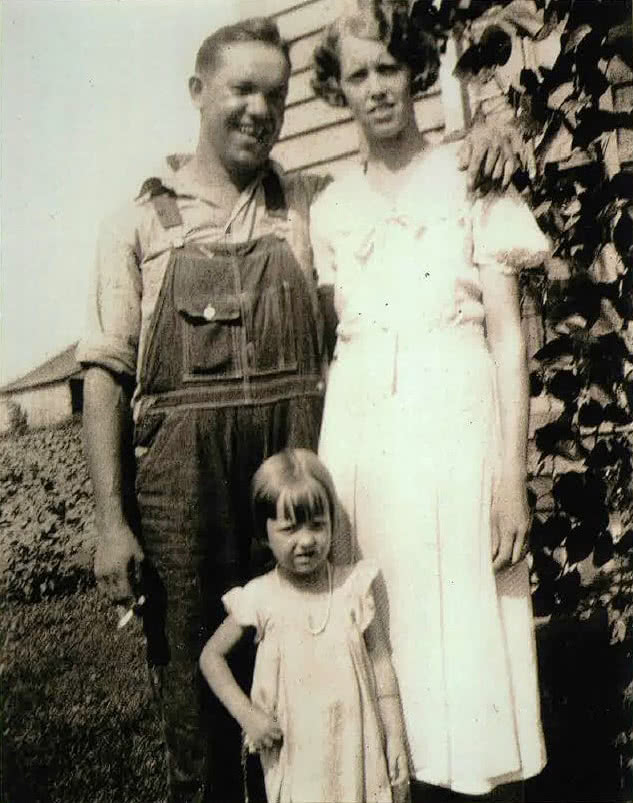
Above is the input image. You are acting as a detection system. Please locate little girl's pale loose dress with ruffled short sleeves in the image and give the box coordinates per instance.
[222,561,392,803]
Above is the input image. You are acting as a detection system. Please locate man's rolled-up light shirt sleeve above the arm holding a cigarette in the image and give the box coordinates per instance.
[77,208,142,376]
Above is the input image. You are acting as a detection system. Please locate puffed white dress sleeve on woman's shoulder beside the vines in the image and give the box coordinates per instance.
[472,188,551,275]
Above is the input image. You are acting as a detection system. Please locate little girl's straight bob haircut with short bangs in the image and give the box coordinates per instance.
[252,449,336,541]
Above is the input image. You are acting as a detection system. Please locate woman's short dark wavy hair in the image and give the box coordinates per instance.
[311,0,440,106]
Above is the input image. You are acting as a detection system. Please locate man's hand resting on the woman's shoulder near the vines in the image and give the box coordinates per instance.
[458,123,522,196]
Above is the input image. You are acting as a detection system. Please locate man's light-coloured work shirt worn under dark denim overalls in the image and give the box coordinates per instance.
[77,156,326,379]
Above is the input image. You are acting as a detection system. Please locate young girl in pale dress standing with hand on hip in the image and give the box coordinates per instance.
[200,449,408,803]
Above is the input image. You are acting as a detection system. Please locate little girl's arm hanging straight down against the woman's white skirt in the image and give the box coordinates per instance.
[365,618,409,786]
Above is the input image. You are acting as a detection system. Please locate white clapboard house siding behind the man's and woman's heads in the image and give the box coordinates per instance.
[269,0,465,175]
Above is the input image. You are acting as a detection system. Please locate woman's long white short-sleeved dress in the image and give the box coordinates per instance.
[311,140,549,794]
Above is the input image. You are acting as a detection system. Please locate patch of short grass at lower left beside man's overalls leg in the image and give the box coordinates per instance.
[0,589,165,803]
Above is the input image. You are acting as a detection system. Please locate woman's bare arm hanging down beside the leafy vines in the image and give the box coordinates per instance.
[479,266,530,571]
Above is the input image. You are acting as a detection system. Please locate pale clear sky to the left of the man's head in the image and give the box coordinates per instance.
[0,0,278,385]
